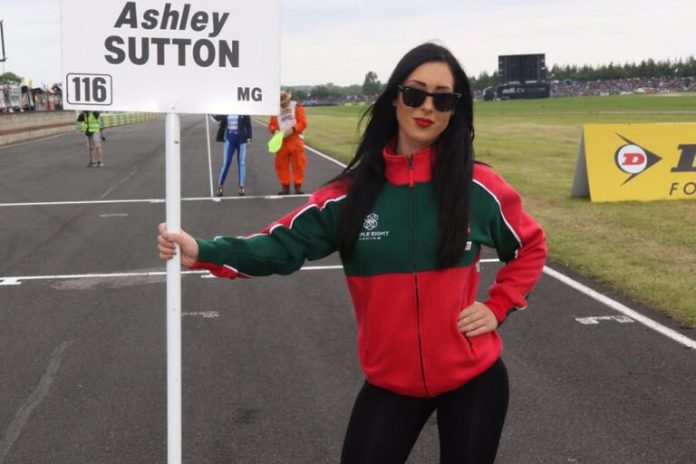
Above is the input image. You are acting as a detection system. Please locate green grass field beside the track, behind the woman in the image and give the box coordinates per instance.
[305,94,696,327]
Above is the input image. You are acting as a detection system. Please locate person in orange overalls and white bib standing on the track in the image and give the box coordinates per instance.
[268,90,307,195]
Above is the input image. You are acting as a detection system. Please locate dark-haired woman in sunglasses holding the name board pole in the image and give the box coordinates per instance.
[158,43,546,464]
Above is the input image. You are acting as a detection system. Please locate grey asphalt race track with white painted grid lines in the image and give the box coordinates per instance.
[0,115,696,464]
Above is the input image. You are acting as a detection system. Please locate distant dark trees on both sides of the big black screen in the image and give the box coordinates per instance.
[470,56,696,90]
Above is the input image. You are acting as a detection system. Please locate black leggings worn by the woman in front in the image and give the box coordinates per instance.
[341,359,510,464]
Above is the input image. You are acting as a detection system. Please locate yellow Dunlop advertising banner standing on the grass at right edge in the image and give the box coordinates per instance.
[572,123,696,201]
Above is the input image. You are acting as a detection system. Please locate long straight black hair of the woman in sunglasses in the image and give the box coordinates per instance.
[333,43,474,269]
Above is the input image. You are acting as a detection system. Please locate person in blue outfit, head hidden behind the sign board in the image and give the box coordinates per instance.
[213,114,252,197]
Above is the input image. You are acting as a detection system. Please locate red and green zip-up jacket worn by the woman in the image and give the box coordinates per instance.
[194,149,546,397]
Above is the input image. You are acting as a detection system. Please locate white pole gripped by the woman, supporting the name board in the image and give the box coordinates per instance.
[165,113,181,464]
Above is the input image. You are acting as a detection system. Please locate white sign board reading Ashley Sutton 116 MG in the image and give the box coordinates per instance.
[61,0,280,114]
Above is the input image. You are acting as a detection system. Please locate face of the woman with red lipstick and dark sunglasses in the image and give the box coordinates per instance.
[394,61,454,155]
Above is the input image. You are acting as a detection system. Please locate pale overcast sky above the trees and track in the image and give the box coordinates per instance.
[0,0,696,85]
